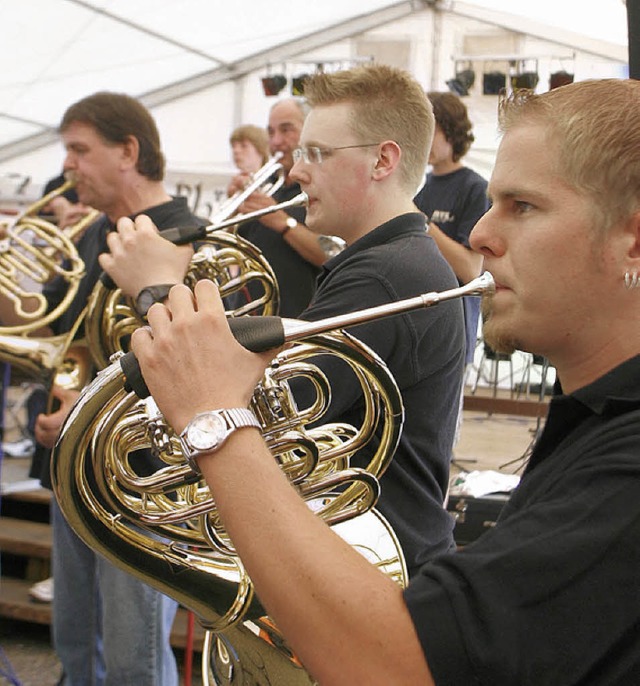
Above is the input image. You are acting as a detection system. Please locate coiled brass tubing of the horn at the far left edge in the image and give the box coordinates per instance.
[0,179,99,335]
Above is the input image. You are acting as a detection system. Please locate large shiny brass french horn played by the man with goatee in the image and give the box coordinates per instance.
[52,273,493,684]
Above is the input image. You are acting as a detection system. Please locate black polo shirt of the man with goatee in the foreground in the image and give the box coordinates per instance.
[405,356,640,686]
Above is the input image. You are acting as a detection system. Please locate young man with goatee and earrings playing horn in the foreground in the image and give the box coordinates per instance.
[133,79,640,686]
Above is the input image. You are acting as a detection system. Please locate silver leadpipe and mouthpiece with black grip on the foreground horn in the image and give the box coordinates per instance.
[119,272,495,398]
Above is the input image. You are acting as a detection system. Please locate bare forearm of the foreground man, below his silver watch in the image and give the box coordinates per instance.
[199,430,433,686]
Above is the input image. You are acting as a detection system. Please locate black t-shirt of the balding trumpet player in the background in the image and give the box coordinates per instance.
[238,183,320,318]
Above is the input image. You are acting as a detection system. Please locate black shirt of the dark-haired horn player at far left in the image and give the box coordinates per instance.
[30,197,206,488]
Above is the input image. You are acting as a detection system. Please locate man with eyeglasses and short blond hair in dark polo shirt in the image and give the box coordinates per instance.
[278,65,464,574]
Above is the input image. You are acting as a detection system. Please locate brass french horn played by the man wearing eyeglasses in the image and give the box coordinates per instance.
[85,193,307,369]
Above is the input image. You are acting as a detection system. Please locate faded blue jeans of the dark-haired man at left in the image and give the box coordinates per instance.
[51,499,178,686]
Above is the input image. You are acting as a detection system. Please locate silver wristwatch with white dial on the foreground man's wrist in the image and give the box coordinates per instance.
[179,407,261,474]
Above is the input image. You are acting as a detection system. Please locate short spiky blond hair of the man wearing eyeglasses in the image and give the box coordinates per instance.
[304,64,435,192]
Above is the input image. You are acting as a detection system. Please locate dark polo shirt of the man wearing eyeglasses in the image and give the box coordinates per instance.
[296,213,464,574]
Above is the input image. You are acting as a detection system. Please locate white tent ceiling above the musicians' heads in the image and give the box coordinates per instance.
[0,0,627,199]
